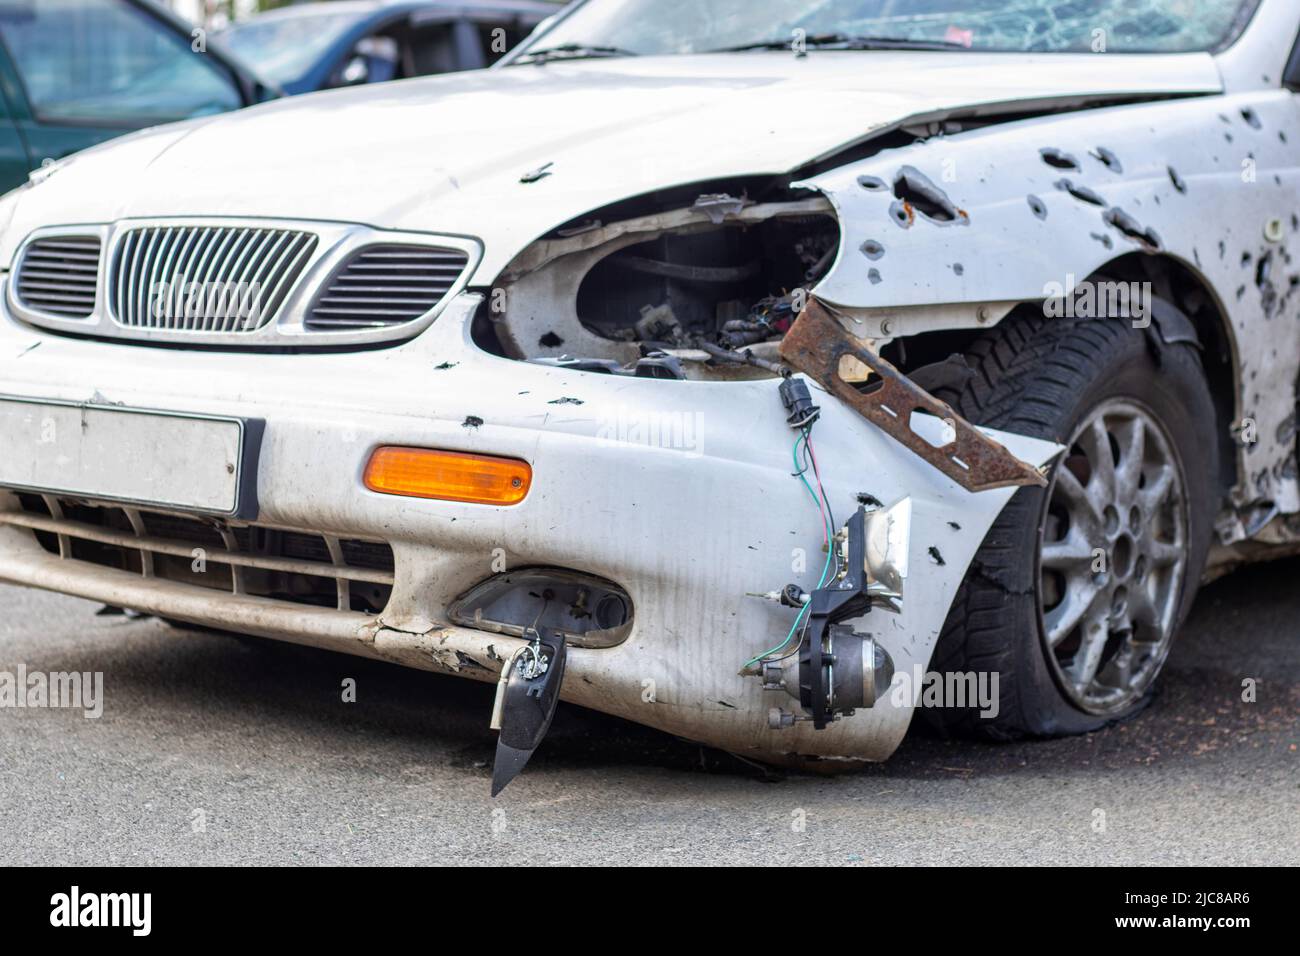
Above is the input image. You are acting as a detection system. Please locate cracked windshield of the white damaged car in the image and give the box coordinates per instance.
[522,0,1263,55]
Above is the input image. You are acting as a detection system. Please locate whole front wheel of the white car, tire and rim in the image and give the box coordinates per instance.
[927,303,1218,739]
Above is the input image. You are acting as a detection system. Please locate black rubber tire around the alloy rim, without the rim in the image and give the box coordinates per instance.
[923,303,1218,740]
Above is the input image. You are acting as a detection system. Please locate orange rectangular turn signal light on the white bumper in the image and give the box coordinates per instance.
[365,445,533,505]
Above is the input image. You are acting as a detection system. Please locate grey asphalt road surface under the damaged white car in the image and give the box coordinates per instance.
[0,561,1300,865]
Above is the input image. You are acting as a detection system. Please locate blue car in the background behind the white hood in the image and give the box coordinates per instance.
[220,0,562,94]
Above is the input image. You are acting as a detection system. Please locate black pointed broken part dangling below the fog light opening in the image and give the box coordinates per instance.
[490,628,568,796]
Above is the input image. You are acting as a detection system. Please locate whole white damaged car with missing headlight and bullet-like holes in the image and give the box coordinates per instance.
[0,0,1300,790]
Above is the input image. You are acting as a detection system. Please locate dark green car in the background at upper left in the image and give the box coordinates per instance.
[0,0,276,193]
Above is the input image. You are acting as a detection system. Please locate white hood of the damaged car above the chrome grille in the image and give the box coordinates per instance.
[0,51,1221,282]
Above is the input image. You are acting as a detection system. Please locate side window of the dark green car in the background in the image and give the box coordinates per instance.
[0,0,243,124]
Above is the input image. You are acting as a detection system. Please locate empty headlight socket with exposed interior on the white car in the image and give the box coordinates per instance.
[475,187,840,378]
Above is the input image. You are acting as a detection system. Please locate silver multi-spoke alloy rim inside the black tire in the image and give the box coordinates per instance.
[1039,399,1188,715]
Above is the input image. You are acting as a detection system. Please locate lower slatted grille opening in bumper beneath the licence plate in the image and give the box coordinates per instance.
[0,494,394,614]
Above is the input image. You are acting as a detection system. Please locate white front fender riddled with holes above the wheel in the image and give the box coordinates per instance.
[794,90,1300,514]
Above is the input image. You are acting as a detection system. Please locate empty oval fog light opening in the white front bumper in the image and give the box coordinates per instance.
[447,567,632,648]
